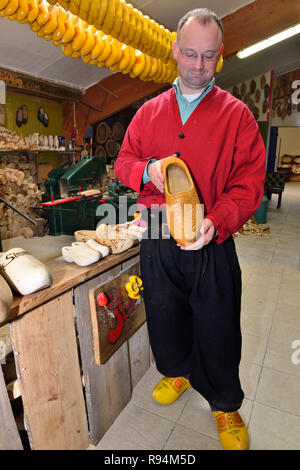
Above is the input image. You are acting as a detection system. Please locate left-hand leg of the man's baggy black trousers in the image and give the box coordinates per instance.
[141,240,193,377]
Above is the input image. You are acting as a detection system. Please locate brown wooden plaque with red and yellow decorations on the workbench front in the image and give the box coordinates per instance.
[89,264,146,365]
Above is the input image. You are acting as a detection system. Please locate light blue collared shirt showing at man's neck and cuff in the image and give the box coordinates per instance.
[143,77,215,184]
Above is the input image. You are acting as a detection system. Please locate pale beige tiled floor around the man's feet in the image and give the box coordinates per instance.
[96,183,300,450]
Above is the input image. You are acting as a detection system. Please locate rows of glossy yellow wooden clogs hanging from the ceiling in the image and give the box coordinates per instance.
[0,0,178,83]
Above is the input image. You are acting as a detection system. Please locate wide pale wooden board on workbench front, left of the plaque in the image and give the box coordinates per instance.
[11,291,89,450]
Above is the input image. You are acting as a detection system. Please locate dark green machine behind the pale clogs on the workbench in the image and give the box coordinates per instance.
[41,156,138,235]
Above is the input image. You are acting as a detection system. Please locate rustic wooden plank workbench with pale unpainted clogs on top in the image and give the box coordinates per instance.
[0,246,150,449]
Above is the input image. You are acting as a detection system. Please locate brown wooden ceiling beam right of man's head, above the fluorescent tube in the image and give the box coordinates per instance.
[222,0,300,58]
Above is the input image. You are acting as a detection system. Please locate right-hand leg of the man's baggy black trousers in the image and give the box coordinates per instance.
[190,239,244,411]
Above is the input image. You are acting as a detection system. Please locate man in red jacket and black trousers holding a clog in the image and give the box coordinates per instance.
[115,9,265,449]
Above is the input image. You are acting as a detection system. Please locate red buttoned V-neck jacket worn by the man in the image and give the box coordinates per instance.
[114,86,265,243]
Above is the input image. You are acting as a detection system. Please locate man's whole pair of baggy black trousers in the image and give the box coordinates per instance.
[140,222,244,412]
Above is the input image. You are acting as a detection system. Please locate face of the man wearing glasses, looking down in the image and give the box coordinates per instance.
[173,18,222,94]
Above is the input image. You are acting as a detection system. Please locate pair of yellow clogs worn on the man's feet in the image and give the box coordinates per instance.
[152,377,249,450]
